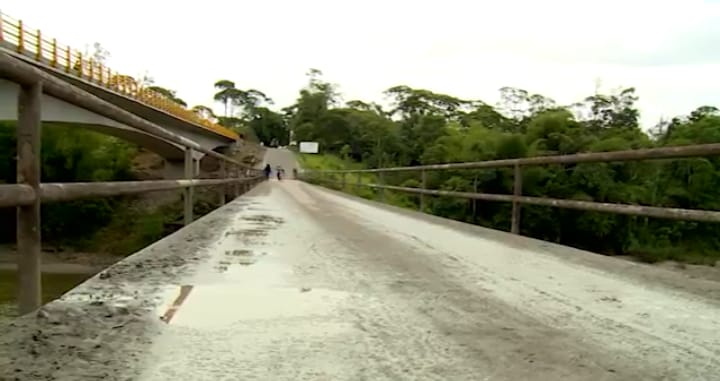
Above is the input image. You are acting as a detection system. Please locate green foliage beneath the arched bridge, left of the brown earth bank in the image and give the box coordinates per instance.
[0,123,136,242]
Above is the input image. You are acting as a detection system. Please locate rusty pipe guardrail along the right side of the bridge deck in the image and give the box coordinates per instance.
[305,144,720,234]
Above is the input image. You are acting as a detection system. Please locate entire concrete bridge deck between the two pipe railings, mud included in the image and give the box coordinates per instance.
[0,150,720,381]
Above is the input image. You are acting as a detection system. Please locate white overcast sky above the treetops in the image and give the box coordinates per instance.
[0,0,720,128]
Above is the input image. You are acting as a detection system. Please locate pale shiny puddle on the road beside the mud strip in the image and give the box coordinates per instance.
[158,205,338,329]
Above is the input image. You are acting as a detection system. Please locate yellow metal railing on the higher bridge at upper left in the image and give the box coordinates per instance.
[0,13,239,140]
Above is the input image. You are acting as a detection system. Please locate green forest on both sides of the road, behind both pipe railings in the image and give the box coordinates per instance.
[0,69,720,264]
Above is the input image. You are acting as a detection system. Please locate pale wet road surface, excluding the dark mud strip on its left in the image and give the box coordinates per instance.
[135,150,720,381]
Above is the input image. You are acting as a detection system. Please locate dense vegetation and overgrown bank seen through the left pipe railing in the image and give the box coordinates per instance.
[0,122,217,255]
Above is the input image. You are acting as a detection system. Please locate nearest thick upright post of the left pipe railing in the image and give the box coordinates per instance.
[17,82,42,314]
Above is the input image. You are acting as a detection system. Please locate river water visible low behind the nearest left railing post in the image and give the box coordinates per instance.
[0,270,93,320]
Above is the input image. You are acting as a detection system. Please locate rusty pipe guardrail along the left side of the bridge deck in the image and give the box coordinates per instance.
[0,52,265,313]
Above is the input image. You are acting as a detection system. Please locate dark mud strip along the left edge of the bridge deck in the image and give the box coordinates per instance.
[0,201,258,381]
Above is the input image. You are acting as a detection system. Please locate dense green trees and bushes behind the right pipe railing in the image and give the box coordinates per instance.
[286,70,720,263]
